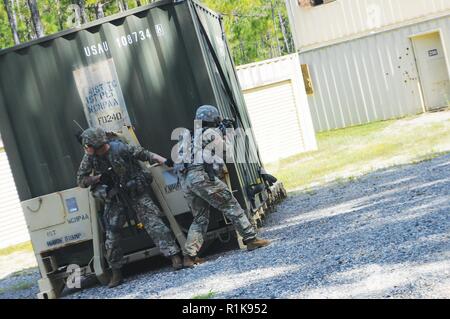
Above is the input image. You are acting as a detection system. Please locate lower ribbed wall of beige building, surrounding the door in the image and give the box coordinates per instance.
[300,14,450,131]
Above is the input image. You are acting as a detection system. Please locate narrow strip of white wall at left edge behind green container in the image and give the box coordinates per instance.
[0,149,30,248]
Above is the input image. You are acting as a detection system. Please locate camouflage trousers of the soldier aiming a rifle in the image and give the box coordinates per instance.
[182,169,256,256]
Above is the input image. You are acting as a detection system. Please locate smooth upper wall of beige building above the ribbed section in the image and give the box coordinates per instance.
[286,0,450,51]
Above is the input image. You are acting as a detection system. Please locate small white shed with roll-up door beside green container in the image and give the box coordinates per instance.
[237,54,317,163]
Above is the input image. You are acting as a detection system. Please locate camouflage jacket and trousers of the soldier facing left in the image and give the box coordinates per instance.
[77,140,180,268]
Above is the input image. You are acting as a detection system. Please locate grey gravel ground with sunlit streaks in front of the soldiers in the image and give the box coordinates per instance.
[0,155,450,299]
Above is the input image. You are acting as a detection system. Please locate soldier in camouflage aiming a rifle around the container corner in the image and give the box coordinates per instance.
[176,105,270,268]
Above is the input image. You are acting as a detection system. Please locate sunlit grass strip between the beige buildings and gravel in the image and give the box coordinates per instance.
[267,112,450,193]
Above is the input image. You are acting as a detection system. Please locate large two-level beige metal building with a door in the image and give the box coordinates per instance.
[287,0,450,131]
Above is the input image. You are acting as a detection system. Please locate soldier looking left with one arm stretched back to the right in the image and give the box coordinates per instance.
[77,128,182,288]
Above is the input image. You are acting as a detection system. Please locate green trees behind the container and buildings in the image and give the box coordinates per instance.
[0,0,294,65]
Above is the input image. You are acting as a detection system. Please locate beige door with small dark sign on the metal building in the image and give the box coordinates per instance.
[412,32,450,111]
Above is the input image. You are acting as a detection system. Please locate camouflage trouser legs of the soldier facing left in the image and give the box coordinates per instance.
[103,194,180,269]
